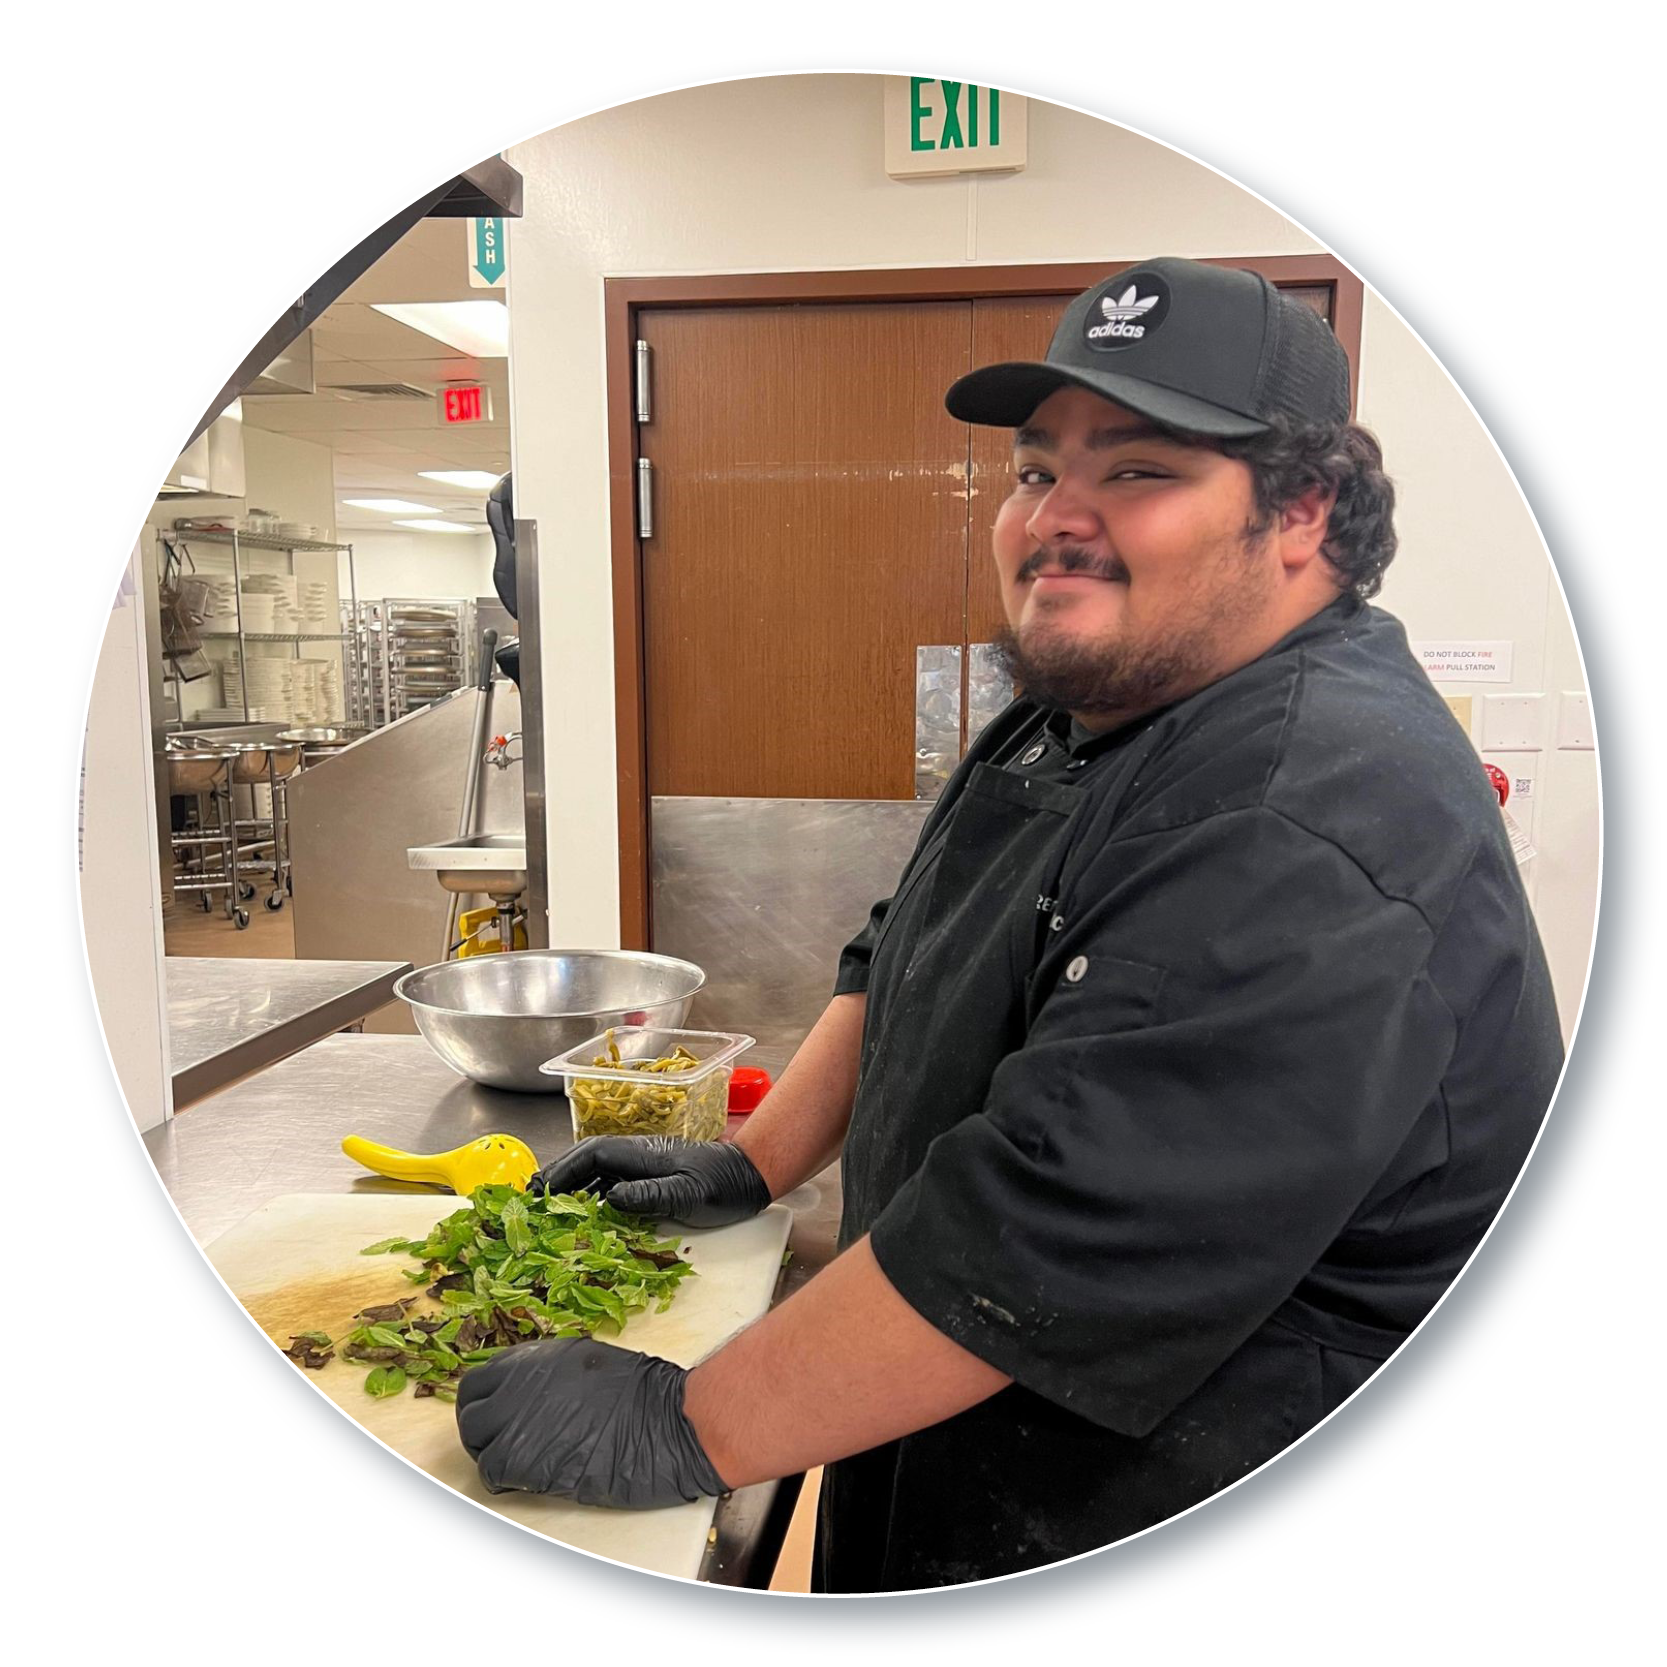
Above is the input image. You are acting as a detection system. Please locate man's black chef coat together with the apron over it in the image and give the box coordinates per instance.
[817,598,1562,1592]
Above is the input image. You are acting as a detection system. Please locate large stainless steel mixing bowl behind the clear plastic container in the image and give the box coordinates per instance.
[393,949,707,1094]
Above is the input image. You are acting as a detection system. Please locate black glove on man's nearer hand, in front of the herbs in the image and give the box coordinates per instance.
[457,1337,727,1510]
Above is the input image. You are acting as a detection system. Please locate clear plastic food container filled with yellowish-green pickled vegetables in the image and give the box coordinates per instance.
[538,1025,753,1140]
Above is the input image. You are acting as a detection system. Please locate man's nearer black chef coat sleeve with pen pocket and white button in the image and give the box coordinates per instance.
[872,807,1455,1435]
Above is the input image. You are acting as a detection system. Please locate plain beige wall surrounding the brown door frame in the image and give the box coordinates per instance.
[508,75,1597,1025]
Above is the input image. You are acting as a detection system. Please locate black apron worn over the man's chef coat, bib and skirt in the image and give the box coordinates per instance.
[817,733,1400,1592]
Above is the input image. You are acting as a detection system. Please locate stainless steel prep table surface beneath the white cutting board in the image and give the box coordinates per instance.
[145,1035,840,1585]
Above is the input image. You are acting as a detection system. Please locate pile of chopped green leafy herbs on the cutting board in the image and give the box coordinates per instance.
[283,1187,693,1400]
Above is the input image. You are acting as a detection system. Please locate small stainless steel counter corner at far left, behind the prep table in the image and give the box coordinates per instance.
[167,955,412,1112]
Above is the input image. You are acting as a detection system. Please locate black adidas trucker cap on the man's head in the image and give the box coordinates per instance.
[944,257,1349,438]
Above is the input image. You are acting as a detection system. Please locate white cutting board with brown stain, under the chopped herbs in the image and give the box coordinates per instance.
[203,1192,793,1579]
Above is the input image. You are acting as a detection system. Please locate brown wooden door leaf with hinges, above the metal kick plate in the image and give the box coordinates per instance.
[638,302,970,798]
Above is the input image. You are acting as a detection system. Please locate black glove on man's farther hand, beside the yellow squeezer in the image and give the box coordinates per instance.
[527,1135,770,1227]
